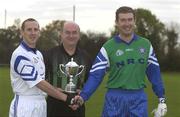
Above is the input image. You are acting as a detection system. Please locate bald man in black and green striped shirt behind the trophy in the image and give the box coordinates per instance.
[45,21,91,117]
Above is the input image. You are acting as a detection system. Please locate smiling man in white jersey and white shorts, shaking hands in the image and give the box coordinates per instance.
[9,18,76,117]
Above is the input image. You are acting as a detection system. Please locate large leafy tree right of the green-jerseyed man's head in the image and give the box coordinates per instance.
[136,8,166,61]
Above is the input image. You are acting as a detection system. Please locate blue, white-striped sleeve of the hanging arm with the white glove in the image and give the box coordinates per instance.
[146,47,165,98]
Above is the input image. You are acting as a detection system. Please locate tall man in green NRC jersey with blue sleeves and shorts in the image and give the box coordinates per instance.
[76,6,167,117]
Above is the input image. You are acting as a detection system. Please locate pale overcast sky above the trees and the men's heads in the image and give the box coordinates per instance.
[0,0,180,32]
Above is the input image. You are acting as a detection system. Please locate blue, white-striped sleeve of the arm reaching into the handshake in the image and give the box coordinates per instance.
[80,49,108,101]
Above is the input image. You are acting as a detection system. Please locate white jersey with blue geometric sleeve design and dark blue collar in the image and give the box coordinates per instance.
[10,42,45,95]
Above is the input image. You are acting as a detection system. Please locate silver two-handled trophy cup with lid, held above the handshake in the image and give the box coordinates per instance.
[59,58,84,93]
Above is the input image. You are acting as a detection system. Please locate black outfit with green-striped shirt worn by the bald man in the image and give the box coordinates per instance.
[44,44,91,117]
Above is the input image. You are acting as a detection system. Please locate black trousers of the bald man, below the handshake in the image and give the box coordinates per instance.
[47,96,85,117]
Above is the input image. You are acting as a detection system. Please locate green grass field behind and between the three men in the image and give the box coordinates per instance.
[0,67,180,117]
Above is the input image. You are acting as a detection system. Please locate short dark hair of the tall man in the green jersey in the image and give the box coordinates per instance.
[116,6,135,21]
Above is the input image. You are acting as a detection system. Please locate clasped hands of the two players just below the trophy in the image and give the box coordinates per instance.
[65,94,84,110]
